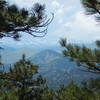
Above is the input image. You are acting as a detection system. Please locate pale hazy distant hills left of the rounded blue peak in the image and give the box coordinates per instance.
[1,47,36,64]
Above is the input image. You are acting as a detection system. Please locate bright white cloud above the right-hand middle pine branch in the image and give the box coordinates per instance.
[64,11,100,42]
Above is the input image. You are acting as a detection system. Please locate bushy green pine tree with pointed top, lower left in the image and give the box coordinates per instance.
[0,55,53,100]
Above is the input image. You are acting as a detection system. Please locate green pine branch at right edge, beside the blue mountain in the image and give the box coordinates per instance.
[60,39,100,73]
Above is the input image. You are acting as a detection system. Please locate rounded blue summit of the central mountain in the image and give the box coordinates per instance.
[29,50,62,65]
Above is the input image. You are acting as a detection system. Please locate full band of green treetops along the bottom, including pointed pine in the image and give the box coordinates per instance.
[0,58,100,100]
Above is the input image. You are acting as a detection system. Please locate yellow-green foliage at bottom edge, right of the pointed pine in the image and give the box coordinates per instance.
[56,82,100,100]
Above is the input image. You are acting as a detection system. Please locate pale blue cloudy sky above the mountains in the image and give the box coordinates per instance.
[0,0,100,46]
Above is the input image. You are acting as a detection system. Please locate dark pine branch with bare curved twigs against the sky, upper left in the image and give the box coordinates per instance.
[0,0,53,40]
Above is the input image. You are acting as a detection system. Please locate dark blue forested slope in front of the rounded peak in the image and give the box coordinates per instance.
[39,66,100,88]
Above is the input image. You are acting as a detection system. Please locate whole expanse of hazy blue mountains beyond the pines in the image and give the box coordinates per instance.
[0,49,100,88]
